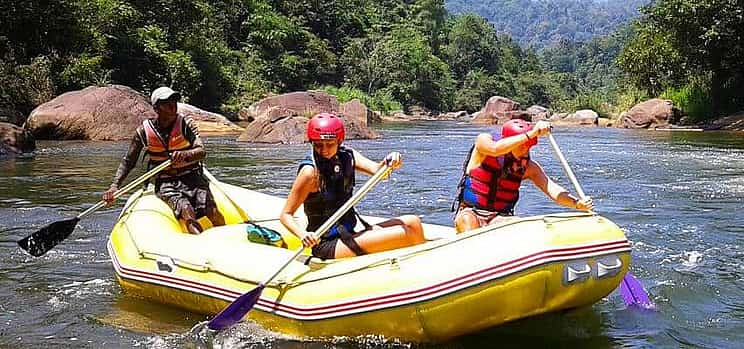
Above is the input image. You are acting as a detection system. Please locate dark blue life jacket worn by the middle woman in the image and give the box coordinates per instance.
[297,146,357,239]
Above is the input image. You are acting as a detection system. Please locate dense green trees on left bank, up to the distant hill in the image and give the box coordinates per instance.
[0,0,576,120]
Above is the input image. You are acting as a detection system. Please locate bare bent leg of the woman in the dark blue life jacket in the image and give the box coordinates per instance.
[335,215,426,258]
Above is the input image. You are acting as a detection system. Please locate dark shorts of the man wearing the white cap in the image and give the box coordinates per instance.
[155,170,217,218]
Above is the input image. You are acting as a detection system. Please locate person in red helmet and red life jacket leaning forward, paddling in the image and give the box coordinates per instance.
[453,119,594,233]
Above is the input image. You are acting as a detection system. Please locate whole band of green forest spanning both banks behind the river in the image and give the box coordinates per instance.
[0,0,744,123]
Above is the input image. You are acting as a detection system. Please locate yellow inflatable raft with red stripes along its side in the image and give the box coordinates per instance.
[108,177,630,342]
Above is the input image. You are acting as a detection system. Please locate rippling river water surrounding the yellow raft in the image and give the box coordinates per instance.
[0,123,744,348]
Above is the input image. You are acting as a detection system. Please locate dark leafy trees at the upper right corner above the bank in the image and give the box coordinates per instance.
[618,0,744,119]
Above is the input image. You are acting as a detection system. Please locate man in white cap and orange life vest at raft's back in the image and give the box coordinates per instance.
[103,87,225,234]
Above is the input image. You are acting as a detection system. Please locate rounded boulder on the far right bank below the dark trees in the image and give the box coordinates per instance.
[617,98,682,128]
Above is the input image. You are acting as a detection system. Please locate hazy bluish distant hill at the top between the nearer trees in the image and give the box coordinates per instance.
[446,0,651,49]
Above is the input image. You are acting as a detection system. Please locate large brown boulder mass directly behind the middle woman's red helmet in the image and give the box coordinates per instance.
[238,91,378,144]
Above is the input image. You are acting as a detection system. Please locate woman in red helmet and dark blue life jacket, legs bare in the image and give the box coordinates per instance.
[280,113,424,259]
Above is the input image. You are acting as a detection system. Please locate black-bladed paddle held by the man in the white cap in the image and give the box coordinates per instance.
[18,160,171,257]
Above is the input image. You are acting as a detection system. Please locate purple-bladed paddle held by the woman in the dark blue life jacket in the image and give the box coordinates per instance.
[207,163,392,331]
